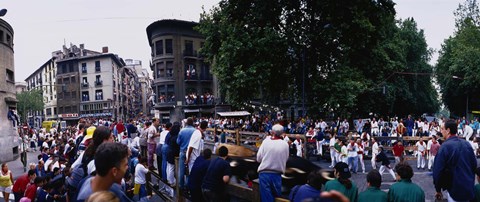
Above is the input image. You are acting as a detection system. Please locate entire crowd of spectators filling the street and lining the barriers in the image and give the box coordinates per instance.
[5,113,480,201]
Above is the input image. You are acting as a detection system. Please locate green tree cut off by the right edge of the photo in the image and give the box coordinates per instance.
[435,0,480,116]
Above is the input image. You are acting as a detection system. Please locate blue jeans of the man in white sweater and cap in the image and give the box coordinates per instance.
[258,173,282,202]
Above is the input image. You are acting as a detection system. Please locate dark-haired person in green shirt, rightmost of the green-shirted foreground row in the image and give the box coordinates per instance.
[388,162,425,202]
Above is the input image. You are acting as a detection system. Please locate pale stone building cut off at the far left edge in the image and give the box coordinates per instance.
[0,19,20,162]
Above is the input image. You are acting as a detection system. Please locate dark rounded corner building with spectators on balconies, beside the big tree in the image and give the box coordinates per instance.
[147,20,216,122]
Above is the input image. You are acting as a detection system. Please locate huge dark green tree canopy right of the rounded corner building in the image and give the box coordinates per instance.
[199,0,438,116]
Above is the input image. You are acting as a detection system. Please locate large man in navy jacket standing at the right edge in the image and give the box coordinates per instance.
[433,120,477,201]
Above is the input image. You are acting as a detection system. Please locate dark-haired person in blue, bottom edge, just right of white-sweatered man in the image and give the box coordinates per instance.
[288,170,323,202]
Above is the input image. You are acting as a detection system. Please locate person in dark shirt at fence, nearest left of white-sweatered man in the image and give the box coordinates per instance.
[202,146,232,202]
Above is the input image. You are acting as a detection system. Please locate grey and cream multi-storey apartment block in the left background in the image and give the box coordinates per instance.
[57,45,125,121]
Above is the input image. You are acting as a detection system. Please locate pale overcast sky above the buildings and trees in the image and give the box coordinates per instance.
[0,0,463,82]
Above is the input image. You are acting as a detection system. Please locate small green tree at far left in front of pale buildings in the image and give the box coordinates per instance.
[17,89,45,122]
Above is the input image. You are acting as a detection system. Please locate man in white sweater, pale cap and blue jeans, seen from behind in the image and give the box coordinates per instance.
[257,124,289,201]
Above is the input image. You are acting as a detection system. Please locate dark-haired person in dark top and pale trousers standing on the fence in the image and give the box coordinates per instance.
[165,122,180,185]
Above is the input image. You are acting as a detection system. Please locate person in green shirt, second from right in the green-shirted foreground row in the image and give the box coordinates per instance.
[358,170,387,202]
